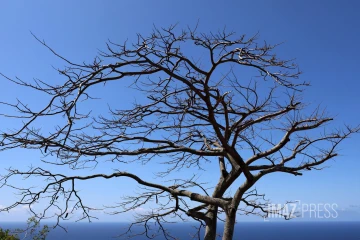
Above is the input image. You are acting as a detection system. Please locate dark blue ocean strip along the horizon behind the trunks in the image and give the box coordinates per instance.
[0,221,360,240]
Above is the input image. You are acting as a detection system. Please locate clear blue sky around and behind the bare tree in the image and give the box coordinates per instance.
[0,0,360,221]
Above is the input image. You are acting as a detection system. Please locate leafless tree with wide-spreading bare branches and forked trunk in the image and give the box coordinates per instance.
[0,26,359,240]
